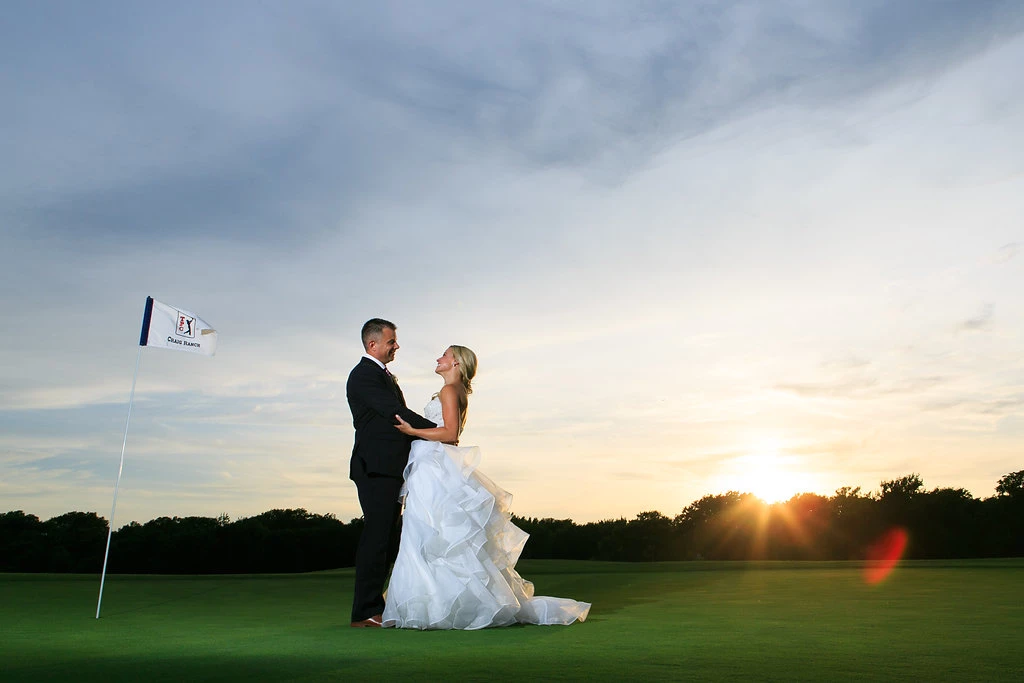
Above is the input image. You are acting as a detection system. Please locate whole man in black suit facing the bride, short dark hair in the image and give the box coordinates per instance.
[346,317,437,628]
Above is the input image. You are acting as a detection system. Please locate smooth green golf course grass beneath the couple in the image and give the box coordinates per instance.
[0,560,1024,683]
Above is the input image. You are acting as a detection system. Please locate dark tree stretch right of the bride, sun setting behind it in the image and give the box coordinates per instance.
[516,470,1024,561]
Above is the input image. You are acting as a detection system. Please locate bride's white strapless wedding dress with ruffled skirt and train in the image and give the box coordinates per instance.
[384,397,590,630]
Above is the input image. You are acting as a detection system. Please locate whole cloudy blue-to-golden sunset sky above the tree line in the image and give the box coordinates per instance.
[0,0,1024,527]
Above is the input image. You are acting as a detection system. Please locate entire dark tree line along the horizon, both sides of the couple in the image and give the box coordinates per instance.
[0,470,1024,573]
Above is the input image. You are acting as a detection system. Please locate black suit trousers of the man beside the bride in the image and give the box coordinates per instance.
[352,475,401,622]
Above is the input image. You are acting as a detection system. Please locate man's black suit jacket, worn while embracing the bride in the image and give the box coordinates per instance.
[345,357,437,479]
